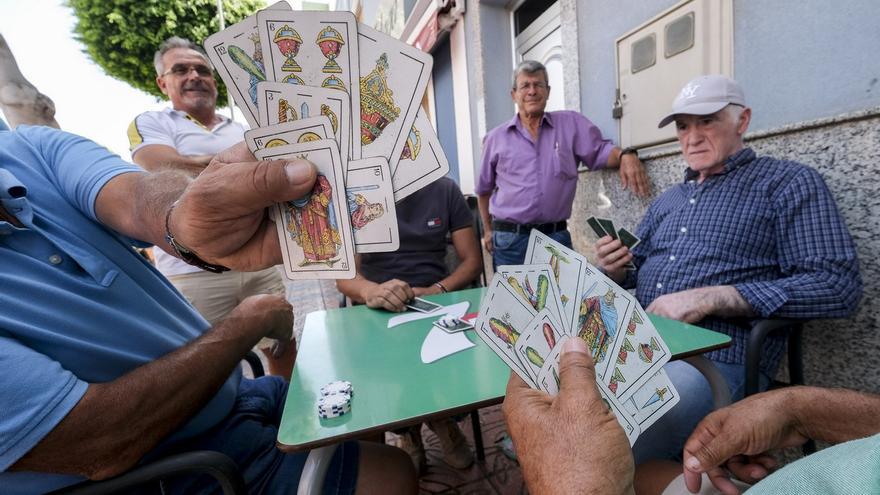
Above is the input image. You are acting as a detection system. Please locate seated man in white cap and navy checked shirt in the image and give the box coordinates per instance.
[596,76,862,464]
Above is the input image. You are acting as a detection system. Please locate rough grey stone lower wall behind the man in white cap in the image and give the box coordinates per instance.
[569,108,880,392]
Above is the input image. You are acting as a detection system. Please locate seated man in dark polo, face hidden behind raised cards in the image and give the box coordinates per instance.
[336,177,482,472]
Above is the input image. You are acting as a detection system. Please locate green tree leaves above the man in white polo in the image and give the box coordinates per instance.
[67,0,265,102]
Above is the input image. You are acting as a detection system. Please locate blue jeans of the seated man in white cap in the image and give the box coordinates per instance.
[633,361,770,466]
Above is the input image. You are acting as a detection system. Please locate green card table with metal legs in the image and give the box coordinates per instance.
[278,289,730,494]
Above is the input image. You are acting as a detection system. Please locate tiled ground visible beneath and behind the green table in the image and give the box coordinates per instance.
[276,280,526,495]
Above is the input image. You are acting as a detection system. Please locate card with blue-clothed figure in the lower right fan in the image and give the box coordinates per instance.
[571,265,638,383]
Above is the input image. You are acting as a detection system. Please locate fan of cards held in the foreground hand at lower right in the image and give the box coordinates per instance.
[475,230,678,444]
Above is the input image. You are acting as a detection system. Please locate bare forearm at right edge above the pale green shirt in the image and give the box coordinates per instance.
[787,387,880,443]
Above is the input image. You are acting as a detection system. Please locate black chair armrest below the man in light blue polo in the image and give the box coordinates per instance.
[50,450,247,495]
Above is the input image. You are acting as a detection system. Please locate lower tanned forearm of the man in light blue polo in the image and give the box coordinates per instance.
[11,309,265,479]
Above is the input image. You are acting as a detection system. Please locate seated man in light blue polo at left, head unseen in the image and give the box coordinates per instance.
[0,127,416,494]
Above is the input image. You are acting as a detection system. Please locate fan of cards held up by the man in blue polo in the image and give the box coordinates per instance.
[205,1,449,279]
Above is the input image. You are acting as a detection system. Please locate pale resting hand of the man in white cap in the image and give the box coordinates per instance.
[646,285,754,323]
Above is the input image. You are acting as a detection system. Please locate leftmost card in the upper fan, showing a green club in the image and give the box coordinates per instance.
[205,1,290,128]
